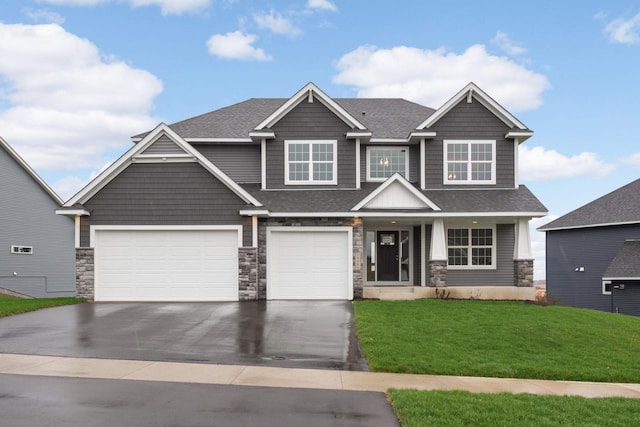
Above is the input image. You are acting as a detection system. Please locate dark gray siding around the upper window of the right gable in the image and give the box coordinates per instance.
[425,100,515,189]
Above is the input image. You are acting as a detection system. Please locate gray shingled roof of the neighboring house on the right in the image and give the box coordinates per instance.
[538,179,640,231]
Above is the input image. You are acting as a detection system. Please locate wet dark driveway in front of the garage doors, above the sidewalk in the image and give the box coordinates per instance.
[0,301,367,370]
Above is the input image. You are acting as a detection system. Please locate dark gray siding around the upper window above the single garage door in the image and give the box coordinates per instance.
[267,100,356,189]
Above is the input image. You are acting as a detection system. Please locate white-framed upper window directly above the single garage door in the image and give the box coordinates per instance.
[284,140,338,185]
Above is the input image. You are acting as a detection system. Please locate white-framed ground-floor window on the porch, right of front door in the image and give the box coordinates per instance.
[447,228,495,268]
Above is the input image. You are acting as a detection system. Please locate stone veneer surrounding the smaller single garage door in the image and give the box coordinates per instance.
[258,218,364,299]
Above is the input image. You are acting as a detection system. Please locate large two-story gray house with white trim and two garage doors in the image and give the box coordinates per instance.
[58,83,546,301]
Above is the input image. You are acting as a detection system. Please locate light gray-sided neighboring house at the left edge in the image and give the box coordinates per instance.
[0,138,75,297]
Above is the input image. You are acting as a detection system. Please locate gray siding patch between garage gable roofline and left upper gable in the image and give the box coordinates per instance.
[191,144,261,184]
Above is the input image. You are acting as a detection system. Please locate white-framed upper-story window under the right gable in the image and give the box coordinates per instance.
[444,140,496,184]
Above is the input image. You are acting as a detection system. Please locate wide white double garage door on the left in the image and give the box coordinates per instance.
[94,229,239,301]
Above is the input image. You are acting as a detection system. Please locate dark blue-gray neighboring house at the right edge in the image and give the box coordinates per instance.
[538,179,640,316]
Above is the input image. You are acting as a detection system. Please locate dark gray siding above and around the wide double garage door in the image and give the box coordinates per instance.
[80,163,251,247]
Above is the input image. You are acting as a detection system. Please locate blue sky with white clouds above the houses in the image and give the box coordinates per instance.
[0,0,640,278]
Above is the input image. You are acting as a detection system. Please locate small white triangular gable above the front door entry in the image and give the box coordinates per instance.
[351,173,440,211]
